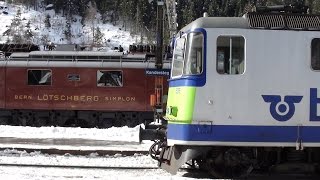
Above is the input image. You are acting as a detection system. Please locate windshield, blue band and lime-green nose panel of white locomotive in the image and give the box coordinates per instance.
[165,29,206,126]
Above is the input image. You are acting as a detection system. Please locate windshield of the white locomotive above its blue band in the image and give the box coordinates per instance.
[172,32,203,77]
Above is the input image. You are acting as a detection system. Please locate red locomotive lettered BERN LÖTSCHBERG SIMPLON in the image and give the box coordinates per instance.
[0,51,170,128]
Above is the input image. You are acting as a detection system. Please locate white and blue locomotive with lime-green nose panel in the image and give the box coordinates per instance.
[142,5,320,178]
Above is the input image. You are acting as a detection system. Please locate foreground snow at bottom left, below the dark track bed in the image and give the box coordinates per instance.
[0,150,198,180]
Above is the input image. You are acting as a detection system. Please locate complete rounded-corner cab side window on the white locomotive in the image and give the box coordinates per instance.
[216,36,245,74]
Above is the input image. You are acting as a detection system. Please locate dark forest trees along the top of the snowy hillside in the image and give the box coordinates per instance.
[6,0,320,29]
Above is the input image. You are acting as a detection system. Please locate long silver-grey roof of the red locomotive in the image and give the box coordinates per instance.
[0,51,171,69]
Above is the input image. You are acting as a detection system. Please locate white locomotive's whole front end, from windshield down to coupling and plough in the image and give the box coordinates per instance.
[151,28,206,174]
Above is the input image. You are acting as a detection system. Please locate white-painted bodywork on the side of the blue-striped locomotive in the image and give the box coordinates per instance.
[168,15,320,146]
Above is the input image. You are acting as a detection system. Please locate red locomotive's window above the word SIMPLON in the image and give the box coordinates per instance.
[97,70,123,87]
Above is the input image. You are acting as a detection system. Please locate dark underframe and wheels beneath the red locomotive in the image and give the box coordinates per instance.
[0,109,154,128]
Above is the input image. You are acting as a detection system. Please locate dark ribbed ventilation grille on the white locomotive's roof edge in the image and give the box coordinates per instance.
[247,13,320,30]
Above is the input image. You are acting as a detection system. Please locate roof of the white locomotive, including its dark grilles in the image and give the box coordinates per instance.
[181,12,320,32]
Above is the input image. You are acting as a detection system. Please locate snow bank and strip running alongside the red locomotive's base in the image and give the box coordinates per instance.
[0,125,153,151]
